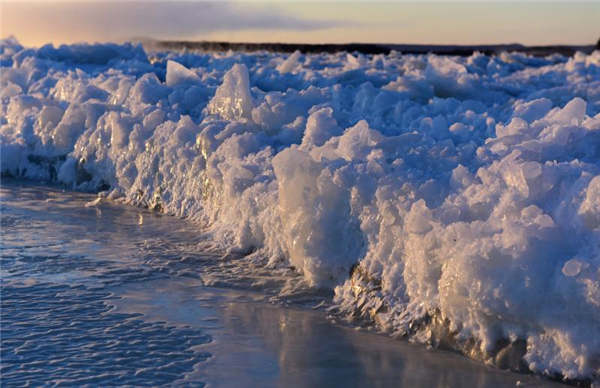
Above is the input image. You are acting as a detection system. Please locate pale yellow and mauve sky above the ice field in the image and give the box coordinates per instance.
[0,0,600,46]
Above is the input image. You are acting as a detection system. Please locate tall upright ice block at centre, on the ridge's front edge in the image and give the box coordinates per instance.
[273,149,363,286]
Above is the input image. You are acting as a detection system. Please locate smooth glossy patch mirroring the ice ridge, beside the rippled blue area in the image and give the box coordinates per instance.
[116,280,561,388]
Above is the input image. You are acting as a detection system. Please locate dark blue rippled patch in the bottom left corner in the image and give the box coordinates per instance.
[0,283,210,386]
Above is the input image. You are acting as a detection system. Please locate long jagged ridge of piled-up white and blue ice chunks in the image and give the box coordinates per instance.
[0,39,600,379]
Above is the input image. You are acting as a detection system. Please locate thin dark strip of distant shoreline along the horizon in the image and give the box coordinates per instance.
[144,41,596,56]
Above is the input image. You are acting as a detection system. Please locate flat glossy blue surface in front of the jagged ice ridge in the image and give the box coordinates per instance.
[0,181,558,387]
